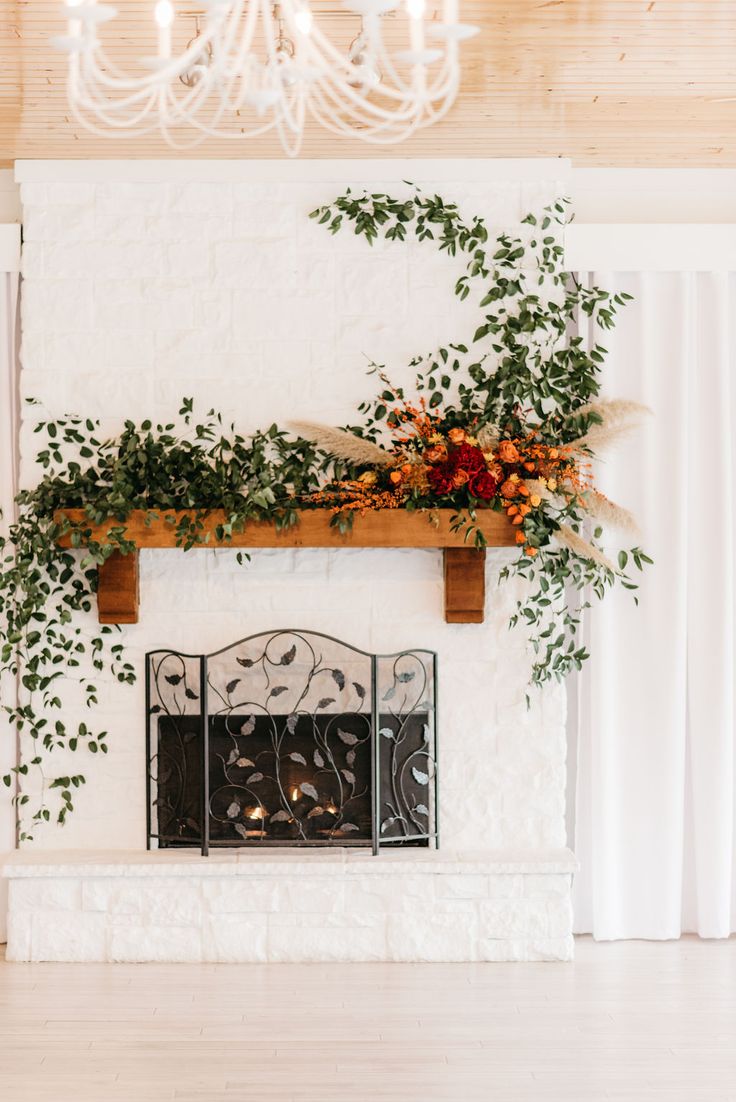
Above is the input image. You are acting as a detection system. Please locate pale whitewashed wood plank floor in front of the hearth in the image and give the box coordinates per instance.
[0,939,736,1102]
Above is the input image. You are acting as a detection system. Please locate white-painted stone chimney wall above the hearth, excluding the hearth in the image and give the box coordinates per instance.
[15,162,565,855]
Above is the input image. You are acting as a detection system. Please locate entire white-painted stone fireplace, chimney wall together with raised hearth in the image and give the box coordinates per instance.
[6,161,574,961]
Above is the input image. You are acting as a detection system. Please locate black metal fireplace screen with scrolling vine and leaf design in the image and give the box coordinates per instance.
[145,630,439,854]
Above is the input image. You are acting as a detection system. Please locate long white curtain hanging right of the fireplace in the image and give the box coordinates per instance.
[575,272,736,939]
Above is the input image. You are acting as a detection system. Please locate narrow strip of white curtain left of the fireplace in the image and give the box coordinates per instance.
[0,264,19,941]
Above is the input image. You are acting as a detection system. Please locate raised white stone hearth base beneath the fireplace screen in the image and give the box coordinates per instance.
[3,850,576,962]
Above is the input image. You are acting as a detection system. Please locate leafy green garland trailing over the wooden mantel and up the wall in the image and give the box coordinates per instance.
[0,188,651,840]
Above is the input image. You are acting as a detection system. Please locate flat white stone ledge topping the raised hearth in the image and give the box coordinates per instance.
[0,847,577,879]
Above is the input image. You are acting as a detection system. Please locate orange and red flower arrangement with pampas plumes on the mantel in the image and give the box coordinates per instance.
[293,387,643,572]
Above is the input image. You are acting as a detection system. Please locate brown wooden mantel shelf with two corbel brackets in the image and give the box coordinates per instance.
[55,509,516,624]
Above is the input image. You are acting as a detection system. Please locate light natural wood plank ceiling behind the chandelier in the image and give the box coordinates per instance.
[0,0,736,168]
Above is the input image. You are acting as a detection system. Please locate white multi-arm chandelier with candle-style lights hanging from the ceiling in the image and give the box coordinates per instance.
[56,0,477,156]
